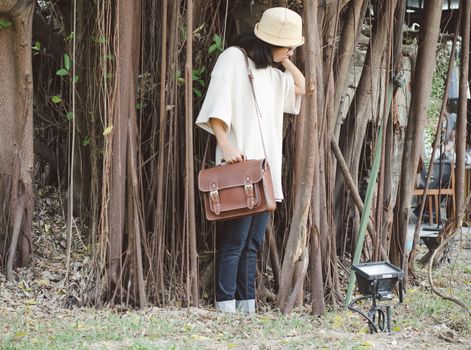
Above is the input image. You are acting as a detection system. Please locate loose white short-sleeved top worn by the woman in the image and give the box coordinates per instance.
[196,47,301,201]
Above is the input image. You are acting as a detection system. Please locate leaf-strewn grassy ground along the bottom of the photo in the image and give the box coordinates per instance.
[0,249,471,350]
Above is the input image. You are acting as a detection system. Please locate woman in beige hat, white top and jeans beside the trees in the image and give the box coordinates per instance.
[196,7,305,313]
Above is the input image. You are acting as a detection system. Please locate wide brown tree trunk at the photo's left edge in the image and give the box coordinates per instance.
[0,0,34,279]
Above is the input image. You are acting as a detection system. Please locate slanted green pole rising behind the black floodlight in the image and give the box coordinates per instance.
[345,82,393,307]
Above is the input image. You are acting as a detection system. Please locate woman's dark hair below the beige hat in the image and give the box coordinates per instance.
[231,32,276,69]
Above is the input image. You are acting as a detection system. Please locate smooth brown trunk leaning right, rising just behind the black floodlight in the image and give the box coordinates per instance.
[390,0,442,280]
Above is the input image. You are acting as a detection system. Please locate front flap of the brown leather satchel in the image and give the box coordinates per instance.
[198,159,268,192]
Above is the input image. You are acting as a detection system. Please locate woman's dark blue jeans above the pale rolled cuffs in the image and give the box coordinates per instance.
[216,212,270,301]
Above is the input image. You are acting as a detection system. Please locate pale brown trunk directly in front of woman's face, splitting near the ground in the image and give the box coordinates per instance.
[277,0,324,313]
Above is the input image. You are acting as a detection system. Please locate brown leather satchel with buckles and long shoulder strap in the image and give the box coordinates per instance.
[198,48,276,221]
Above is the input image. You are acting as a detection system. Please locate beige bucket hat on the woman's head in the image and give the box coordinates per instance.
[254,7,304,47]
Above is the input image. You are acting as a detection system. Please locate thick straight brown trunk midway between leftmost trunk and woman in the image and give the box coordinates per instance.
[105,0,144,304]
